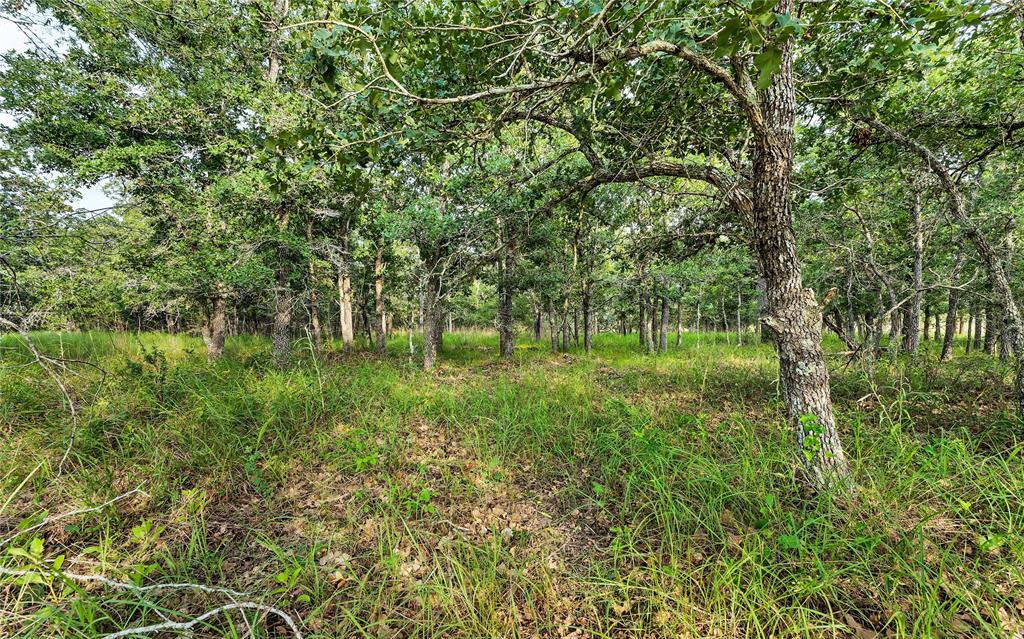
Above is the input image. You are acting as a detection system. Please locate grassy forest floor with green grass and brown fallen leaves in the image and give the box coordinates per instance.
[0,333,1024,639]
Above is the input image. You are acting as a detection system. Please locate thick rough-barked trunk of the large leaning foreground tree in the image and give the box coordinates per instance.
[752,14,850,491]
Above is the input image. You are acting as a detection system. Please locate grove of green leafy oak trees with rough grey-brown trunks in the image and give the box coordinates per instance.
[0,0,1024,497]
